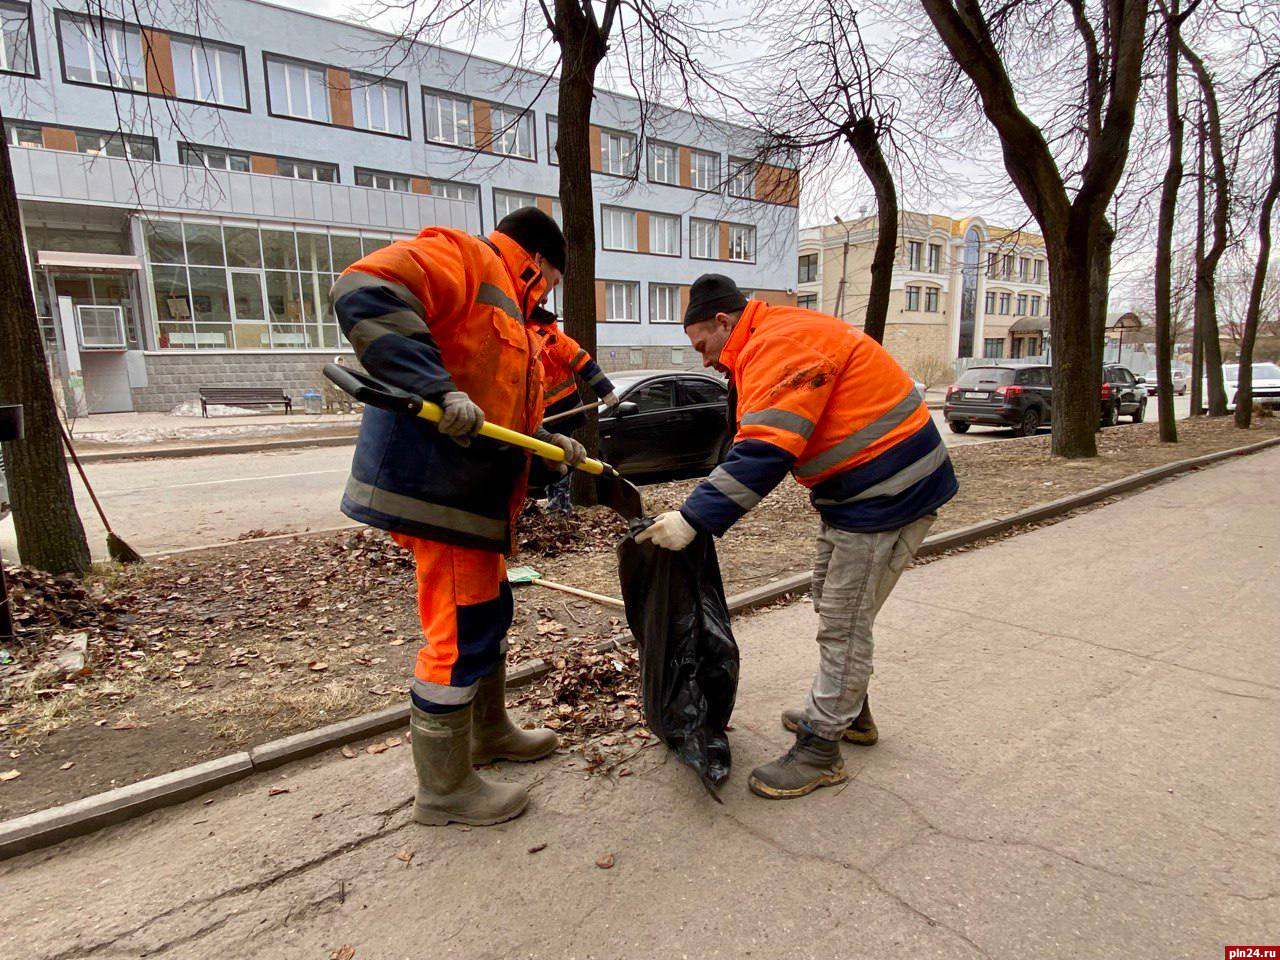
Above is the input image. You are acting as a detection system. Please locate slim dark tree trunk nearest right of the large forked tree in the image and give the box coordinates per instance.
[1156,0,1183,443]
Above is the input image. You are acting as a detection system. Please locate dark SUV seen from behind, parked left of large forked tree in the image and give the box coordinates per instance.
[942,364,1053,436]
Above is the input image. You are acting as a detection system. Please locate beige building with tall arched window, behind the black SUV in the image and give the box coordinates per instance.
[796,211,1050,369]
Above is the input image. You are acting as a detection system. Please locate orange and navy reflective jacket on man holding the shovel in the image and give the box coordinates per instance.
[332,227,547,552]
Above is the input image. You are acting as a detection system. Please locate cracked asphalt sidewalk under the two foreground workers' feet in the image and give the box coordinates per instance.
[0,451,1280,960]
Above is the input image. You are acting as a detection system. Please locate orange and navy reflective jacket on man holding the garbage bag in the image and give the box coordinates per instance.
[680,301,957,534]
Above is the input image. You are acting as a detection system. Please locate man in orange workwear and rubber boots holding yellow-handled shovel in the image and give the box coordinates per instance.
[332,207,586,824]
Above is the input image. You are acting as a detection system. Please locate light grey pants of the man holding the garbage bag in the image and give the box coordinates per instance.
[805,513,938,740]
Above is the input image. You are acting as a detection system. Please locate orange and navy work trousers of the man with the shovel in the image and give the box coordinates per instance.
[392,534,513,713]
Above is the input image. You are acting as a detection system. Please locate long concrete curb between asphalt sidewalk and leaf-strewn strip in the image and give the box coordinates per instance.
[0,436,1280,860]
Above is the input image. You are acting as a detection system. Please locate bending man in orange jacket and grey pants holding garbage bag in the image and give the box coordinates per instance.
[636,274,957,799]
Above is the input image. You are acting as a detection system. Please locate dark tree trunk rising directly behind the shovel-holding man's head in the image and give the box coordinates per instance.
[556,0,607,506]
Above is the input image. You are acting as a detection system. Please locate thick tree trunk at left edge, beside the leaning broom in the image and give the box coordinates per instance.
[0,108,90,575]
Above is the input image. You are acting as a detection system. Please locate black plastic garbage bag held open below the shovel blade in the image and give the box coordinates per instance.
[618,518,737,800]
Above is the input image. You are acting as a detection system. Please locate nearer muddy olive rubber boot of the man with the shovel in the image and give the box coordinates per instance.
[410,704,529,827]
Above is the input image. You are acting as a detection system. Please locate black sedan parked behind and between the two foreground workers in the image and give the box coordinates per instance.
[600,370,733,475]
